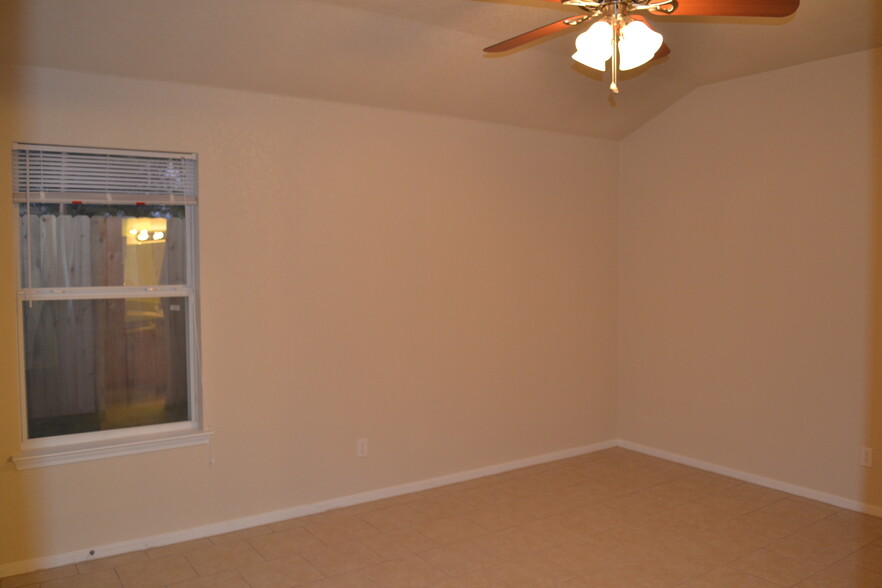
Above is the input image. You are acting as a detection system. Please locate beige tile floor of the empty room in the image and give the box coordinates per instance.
[0,449,882,588]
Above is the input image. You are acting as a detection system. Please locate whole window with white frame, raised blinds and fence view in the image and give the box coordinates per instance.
[13,144,207,468]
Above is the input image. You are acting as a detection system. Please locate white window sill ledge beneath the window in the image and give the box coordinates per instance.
[12,431,211,470]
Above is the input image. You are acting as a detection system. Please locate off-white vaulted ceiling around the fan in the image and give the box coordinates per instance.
[0,0,882,139]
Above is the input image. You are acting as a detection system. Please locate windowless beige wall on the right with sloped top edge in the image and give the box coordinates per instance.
[619,51,882,507]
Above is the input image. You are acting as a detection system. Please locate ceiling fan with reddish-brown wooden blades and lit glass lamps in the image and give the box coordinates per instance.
[484,0,799,94]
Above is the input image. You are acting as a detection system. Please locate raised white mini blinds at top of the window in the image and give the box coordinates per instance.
[12,143,198,205]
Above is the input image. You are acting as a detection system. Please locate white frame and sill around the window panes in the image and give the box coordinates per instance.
[12,143,211,470]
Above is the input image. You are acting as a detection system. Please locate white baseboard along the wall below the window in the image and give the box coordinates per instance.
[0,440,618,578]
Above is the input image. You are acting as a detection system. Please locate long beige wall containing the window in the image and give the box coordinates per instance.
[0,65,618,564]
